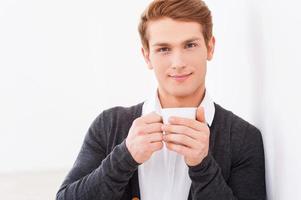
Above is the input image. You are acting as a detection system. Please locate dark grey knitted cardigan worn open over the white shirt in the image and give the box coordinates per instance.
[56,103,266,200]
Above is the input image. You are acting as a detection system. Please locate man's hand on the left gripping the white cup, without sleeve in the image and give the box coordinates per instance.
[126,112,163,164]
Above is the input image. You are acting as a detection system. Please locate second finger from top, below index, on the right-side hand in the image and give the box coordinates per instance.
[162,124,200,139]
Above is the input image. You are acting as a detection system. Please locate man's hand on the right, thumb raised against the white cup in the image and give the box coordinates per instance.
[162,107,210,166]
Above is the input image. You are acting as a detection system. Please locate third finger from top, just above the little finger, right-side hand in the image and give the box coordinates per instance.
[163,134,199,149]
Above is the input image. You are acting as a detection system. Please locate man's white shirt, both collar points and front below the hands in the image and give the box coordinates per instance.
[138,90,215,200]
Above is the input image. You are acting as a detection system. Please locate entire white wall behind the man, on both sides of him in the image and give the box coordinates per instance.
[0,0,301,200]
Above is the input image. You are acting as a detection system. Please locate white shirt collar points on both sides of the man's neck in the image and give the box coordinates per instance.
[142,89,215,126]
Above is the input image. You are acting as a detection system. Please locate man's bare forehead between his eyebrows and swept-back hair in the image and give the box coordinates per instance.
[147,18,203,46]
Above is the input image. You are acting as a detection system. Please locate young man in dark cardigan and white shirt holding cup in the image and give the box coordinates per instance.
[57,0,266,200]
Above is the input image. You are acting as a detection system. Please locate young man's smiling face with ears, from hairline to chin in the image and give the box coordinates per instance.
[142,18,214,97]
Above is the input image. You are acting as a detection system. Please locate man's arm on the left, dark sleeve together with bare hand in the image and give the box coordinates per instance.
[57,112,163,200]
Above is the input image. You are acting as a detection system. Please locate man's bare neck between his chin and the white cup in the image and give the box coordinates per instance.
[158,86,205,108]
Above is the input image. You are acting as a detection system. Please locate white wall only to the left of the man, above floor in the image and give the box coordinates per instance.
[0,0,155,171]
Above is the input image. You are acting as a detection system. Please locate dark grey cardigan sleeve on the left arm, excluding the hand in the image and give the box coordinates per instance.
[56,113,138,200]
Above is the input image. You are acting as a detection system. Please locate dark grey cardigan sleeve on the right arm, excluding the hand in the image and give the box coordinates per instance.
[189,126,266,200]
